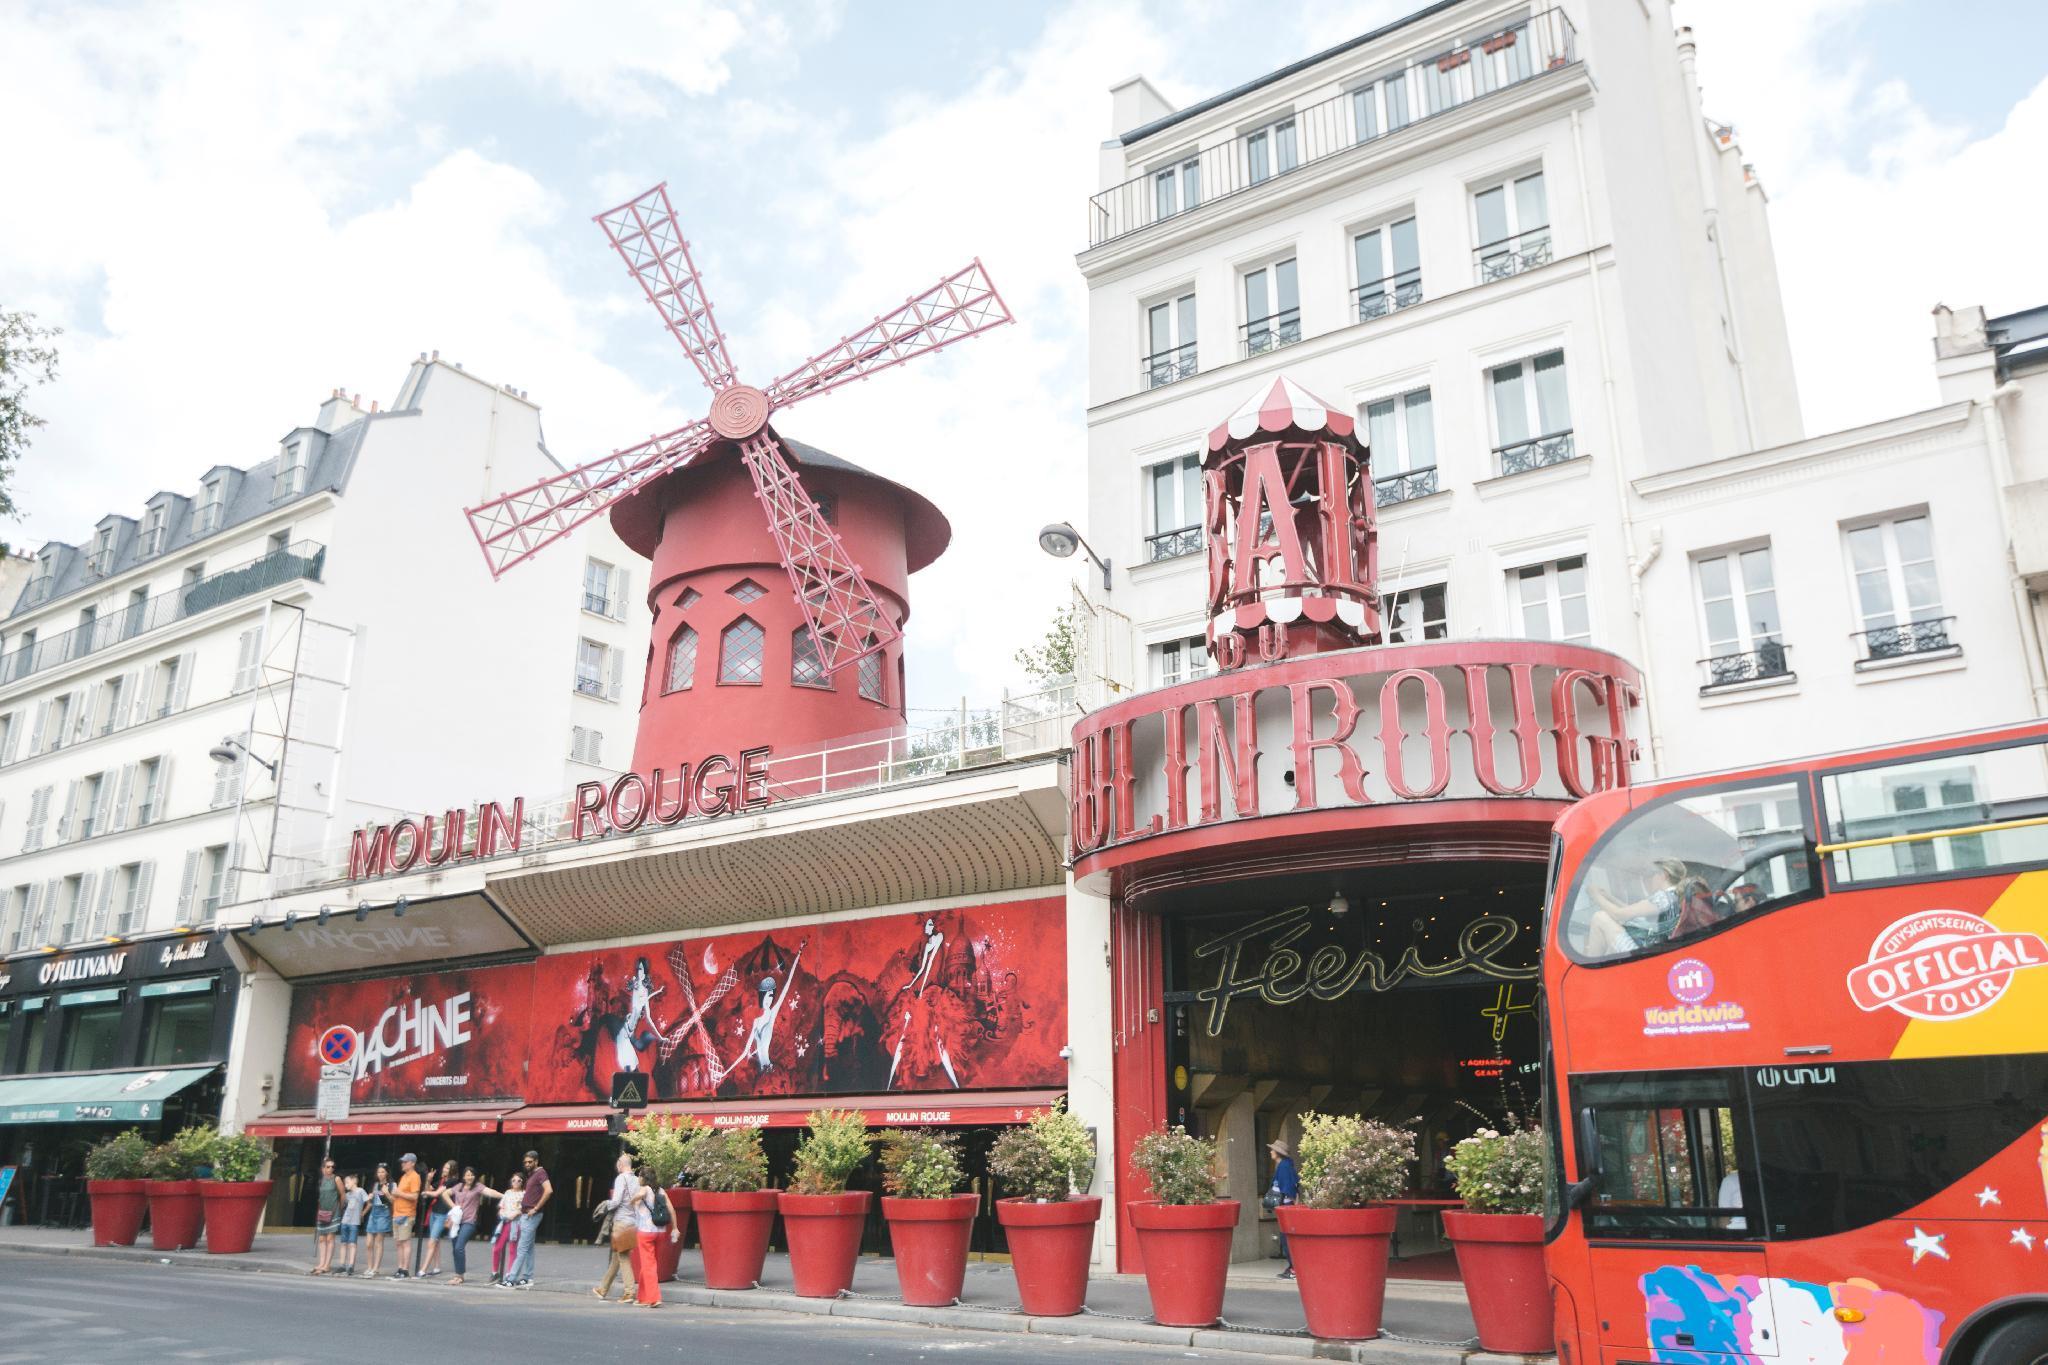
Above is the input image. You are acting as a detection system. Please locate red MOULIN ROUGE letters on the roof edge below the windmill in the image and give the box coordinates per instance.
[348,745,774,882]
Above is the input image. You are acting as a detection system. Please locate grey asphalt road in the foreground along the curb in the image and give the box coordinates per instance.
[0,1254,1251,1365]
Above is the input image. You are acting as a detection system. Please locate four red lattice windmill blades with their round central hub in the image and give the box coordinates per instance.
[467,184,1016,687]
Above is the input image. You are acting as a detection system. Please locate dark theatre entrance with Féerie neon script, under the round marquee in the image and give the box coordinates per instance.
[1155,862,1542,1279]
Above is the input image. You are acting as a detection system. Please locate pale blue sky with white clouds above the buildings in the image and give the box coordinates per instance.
[0,0,2048,706]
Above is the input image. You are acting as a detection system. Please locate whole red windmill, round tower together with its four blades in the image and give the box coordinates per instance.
[467,184,1014,774]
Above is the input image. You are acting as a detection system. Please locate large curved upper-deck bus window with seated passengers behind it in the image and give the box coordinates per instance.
[1565,778,1812,962]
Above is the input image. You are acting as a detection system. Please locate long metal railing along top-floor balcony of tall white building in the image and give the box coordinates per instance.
[1087,10,1579,246]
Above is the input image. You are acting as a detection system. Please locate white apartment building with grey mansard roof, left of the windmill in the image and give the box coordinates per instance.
[0,356,647,970]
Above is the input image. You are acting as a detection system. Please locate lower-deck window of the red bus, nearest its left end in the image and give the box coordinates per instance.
[1573,1070,1763,1238]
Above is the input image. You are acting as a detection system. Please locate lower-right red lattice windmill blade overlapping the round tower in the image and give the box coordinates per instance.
[739,428,901,675]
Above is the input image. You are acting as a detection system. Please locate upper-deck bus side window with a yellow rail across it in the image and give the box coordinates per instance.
[1821,743,2048,886]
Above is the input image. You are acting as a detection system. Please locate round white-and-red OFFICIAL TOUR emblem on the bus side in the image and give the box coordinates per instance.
[1849,911,2048,1023]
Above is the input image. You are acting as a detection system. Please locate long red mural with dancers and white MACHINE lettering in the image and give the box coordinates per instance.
[283,898,1067,1107]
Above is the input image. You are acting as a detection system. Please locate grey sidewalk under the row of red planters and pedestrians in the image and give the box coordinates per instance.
[0,1228,1522,1365]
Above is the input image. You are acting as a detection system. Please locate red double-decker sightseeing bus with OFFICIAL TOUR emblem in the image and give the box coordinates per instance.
[1544,722,2048,1365]
